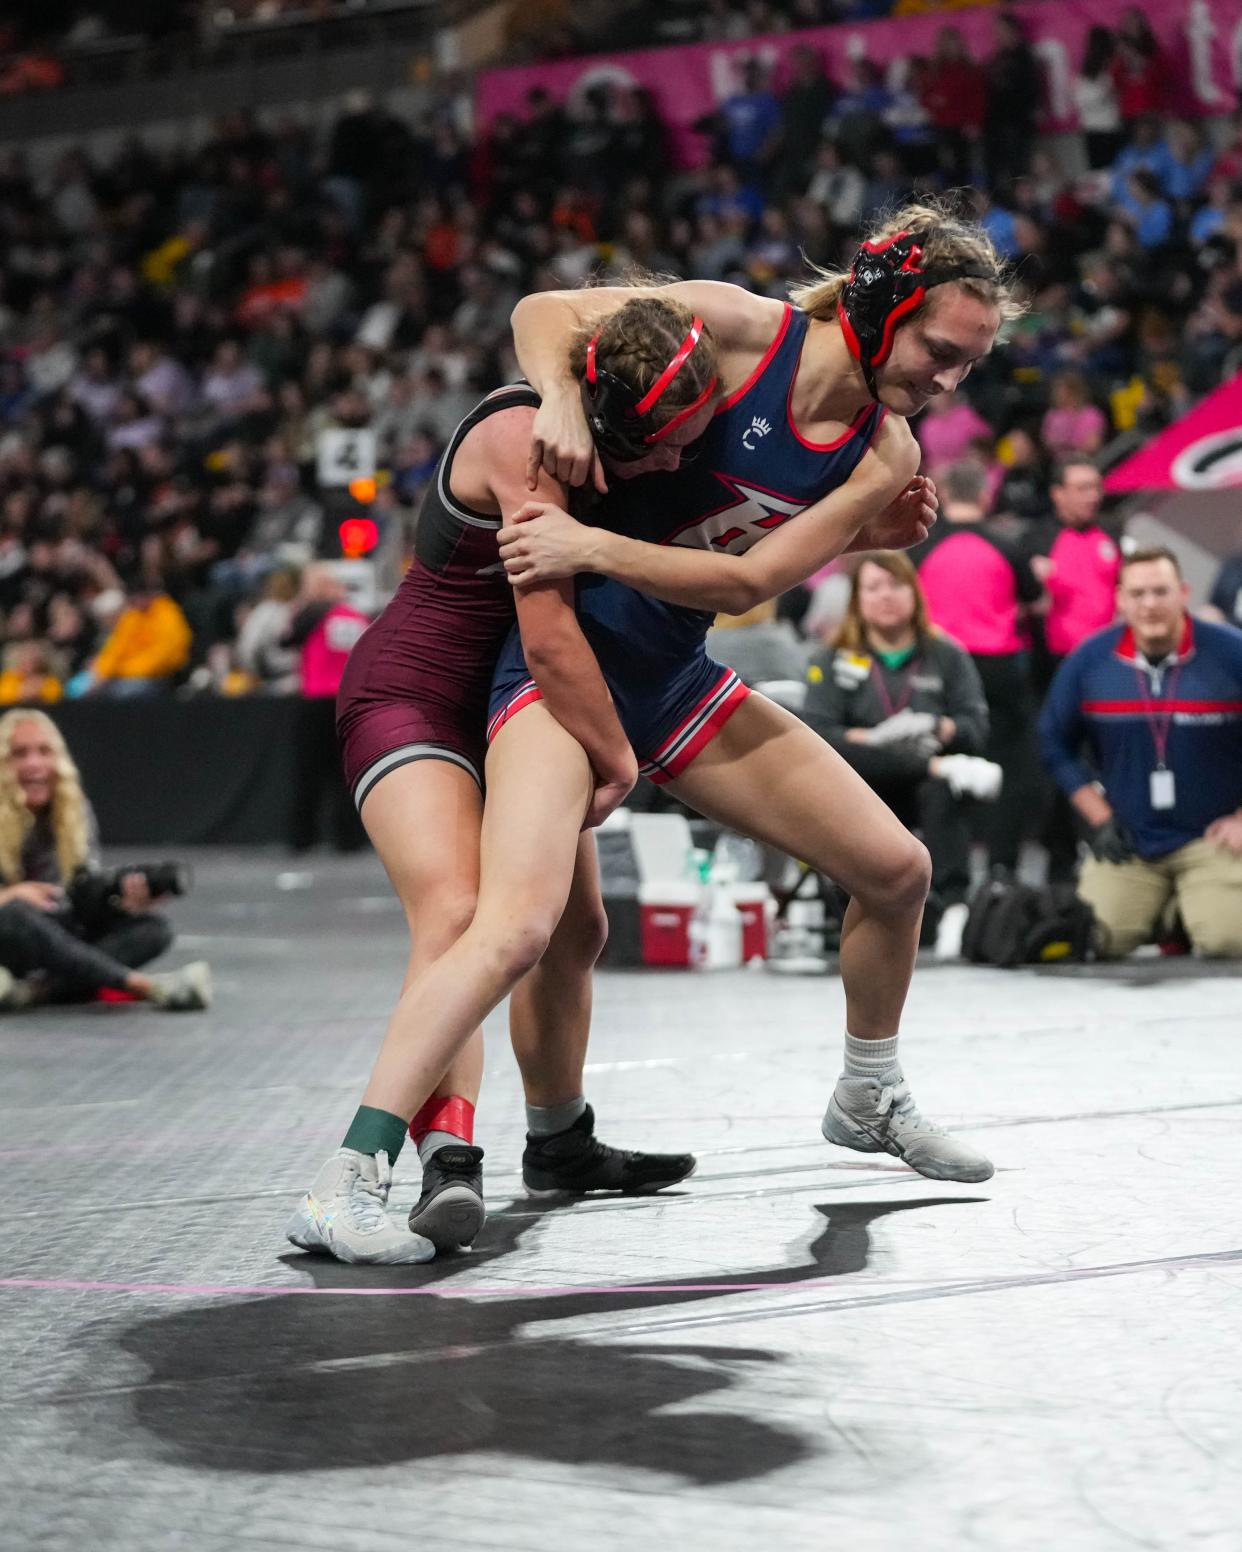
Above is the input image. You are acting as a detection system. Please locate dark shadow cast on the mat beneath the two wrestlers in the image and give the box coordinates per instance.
[92,1197,983,1484]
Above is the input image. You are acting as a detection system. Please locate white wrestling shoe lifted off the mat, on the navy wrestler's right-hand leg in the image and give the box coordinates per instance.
[823,1068,994,1181]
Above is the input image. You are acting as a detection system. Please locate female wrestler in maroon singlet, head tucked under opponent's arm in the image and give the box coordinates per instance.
[287,296,717,1262]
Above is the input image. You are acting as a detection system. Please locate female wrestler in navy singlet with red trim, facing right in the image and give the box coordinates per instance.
[305,206,1008,1254]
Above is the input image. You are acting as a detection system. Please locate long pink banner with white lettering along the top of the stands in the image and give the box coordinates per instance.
[477,0,1242,168]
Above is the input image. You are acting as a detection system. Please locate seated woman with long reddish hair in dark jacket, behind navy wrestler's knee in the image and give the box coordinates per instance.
[803,551,1001,959]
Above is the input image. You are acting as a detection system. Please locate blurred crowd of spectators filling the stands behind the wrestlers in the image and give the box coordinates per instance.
[0,5,1242,869]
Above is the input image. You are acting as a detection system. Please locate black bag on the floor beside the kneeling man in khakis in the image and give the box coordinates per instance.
[961,878,1096,970]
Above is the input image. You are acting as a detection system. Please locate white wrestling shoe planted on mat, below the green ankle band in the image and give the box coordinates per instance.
[284,1148,436,1266]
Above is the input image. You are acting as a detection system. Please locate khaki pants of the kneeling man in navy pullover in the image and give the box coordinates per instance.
[1077,841,1242,959]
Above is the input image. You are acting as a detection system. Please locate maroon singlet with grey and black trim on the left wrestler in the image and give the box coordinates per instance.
[337,383,539,807]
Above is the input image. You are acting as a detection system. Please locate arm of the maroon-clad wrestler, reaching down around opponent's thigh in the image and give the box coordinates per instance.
[487,416,638,801]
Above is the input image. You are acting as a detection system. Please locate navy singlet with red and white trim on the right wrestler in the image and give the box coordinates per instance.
[487,306,886,782]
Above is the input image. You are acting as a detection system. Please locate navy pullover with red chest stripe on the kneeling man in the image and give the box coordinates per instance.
[1039,619,1242,858]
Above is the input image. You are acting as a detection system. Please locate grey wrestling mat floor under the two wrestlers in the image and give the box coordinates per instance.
[0,852,1242,1552]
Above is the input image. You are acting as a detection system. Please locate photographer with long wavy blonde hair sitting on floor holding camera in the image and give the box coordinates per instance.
[0,709,211,1012]
